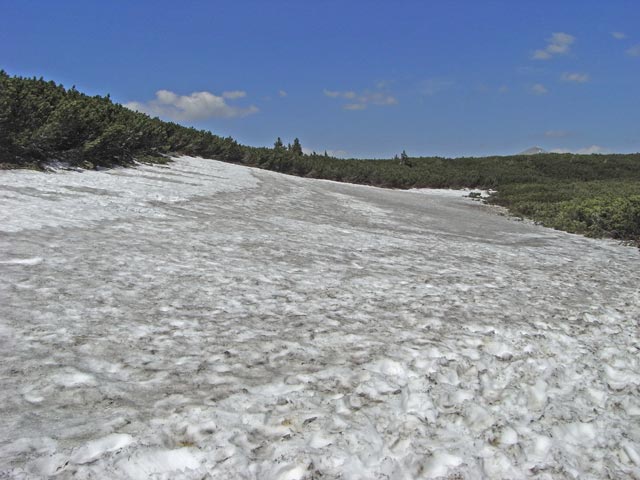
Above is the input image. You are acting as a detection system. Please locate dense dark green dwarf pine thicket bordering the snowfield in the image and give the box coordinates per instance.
[0,71,640,242]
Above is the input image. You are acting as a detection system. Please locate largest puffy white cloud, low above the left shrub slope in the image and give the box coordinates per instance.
[124,90,258,120]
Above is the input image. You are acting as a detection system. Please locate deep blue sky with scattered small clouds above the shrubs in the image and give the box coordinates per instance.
[0,0,640,158]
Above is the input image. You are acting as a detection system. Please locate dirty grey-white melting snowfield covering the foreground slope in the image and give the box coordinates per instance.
[0,157,640,480]
